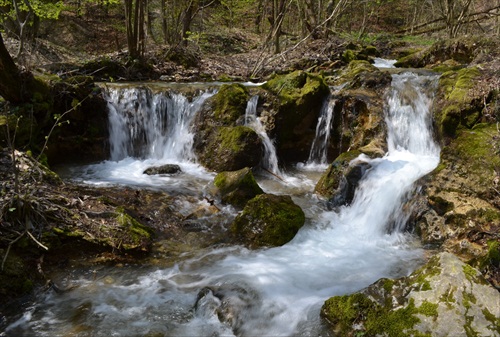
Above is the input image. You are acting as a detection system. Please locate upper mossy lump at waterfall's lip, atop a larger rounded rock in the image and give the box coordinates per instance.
[213,84,249,125]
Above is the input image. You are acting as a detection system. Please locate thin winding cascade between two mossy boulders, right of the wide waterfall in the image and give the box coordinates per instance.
[245,95,284,176]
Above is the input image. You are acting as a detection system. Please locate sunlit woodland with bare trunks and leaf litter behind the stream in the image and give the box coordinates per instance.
[0,0,500,72]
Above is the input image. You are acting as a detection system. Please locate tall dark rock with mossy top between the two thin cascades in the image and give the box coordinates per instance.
[262,71,330,162]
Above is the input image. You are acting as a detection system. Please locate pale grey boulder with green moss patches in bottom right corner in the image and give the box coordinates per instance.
[321,253,500,337]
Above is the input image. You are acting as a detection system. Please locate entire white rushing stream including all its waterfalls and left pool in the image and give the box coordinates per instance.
[0,72,440,337]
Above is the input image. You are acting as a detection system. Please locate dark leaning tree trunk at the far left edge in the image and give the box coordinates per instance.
[0,33,23,104]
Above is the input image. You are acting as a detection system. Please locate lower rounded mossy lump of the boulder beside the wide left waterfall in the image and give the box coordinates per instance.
[198,125,262,172]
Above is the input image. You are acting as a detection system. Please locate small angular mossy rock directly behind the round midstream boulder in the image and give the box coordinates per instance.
[214,167,264,208]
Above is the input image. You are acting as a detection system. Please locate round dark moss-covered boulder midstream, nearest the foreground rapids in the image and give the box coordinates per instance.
[231,194,305,248]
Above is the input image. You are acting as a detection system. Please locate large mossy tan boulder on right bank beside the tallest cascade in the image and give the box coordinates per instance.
[413,124,500,286]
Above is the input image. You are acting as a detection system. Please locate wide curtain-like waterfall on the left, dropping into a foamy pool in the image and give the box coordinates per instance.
[107,87,214,161]
